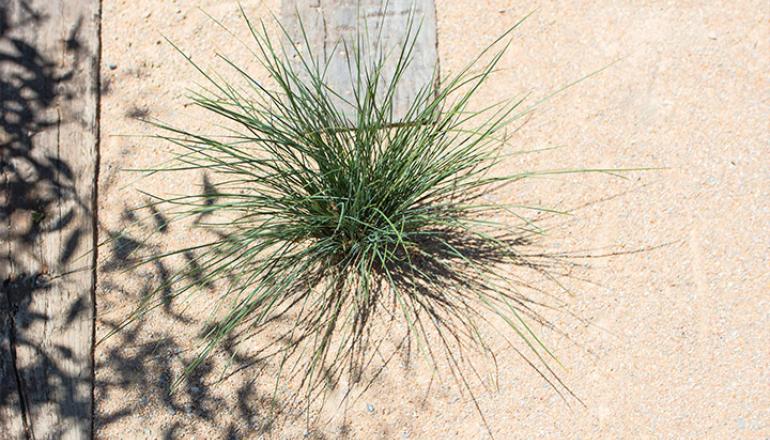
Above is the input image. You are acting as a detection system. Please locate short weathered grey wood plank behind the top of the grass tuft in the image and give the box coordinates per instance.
[281,0,438,120]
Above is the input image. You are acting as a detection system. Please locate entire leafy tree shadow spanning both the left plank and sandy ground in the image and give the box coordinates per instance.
[0,6,272,438]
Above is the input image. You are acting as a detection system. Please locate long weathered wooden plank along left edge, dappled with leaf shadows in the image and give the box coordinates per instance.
[0,0,100,439]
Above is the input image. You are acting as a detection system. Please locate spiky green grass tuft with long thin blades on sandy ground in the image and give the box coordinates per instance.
[108,9,617,430]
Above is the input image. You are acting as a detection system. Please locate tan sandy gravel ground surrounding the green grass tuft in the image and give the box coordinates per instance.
[96,0,770,439]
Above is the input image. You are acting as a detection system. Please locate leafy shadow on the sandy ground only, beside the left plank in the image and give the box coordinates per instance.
[94,197,314,439]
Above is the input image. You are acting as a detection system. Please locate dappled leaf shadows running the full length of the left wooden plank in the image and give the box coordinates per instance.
[0,0,93,438]
